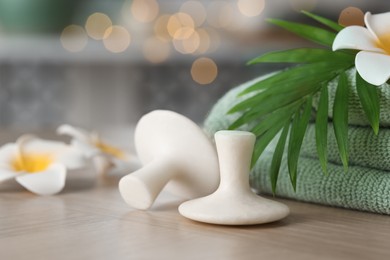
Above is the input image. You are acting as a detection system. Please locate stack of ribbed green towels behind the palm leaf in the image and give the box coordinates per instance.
[204,70,390,214]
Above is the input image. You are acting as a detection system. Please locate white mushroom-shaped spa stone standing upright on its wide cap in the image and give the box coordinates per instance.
[179,131,289,225]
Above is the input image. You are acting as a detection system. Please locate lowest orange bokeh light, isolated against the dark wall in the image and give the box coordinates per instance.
[191,57,218,85]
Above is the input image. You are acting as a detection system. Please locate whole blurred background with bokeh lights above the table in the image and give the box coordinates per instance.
[0,0,390,138]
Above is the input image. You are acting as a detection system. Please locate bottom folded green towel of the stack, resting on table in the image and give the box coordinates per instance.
[250,153,390,214]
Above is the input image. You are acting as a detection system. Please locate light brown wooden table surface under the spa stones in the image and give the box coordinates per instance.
[0,172,390,260]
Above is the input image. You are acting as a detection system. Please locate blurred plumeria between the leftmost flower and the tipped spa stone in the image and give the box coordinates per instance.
[57,125,139,175]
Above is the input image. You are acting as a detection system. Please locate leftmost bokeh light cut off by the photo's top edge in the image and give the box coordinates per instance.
[131,0,160,23]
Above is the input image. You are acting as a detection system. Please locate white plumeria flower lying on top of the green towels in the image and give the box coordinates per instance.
[333,12,390,86]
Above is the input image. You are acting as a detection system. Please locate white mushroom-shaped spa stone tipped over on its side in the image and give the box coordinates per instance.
[119,110,219,209]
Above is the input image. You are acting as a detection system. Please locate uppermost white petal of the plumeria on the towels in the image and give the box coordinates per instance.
[364,12,390,42]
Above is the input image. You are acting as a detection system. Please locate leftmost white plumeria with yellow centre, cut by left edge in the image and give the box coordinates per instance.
[0,135,85,195]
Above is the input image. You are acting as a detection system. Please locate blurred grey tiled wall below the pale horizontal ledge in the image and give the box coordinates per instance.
[0,61,280,130]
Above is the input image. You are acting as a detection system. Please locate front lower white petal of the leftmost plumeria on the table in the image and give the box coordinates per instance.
[16,163,66,195]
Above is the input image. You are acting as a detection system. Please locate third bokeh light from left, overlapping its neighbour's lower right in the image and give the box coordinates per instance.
[103,25,131,53]
